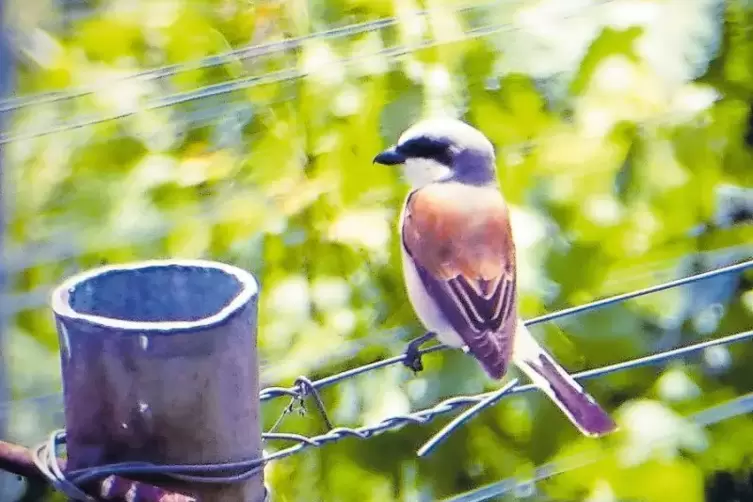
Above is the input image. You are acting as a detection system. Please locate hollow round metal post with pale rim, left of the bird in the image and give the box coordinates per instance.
[52,260,266,502]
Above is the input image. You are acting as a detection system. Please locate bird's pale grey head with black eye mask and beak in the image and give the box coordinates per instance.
[374,118,496,188]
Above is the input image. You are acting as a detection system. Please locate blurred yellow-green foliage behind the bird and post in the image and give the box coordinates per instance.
[0,0,753,502]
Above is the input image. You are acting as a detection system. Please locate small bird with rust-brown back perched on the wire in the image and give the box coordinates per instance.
[373,117,617,437]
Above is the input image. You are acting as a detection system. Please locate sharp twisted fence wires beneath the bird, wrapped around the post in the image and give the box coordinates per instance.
[27,260,753,498]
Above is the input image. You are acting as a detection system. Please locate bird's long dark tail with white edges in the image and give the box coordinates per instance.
[513,321,617,436]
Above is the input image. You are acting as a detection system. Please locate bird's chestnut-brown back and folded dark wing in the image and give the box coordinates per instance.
[402,183,517,378]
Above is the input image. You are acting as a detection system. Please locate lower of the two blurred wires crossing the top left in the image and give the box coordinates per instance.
[0,0,616,145]
